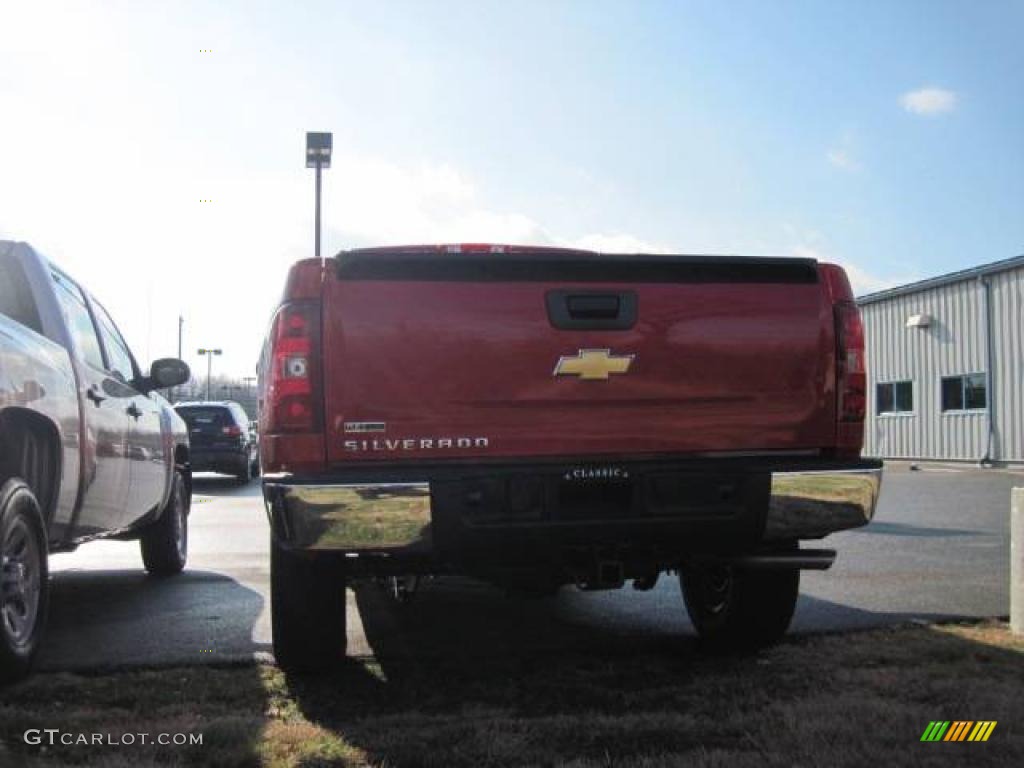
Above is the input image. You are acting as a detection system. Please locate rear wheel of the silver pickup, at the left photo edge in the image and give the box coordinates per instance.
[0,478,50,684]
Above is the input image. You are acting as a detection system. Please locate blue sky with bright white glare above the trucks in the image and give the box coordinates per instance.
[0,0,1024,375]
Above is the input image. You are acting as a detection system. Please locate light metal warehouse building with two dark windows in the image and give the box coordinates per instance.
[857,256,1024,463]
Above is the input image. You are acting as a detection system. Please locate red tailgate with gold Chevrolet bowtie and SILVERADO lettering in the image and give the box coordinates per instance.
[322,248,836,463]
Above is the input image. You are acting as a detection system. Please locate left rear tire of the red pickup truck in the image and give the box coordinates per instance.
[270,537,346,673]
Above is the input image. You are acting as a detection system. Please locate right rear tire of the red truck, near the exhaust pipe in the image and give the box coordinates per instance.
[679,565,800,652]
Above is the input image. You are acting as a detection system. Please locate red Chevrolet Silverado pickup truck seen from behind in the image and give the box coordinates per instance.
[259,245,882,670]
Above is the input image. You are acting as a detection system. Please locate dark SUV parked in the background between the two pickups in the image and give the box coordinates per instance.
[174,400,259,483]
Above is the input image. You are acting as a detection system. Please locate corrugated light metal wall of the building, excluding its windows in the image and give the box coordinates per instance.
[861,268,1024,462]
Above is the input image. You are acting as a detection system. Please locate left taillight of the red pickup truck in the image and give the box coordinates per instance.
[264,301,323,432]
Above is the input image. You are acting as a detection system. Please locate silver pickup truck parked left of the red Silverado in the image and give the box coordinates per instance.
[0,241,191,682]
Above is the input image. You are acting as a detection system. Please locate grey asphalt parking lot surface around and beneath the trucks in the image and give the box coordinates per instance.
[39,466,1024,670]
